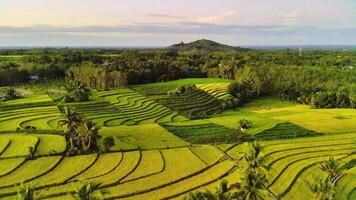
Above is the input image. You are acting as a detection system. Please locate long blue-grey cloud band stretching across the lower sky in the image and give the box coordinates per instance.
[0,22,356,37]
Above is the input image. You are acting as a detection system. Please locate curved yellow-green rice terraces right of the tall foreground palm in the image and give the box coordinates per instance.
[228,134,356,199]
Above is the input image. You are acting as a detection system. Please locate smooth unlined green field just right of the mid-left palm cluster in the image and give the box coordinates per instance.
[100,124,188,150]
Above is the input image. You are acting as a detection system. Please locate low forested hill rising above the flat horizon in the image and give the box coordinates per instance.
[164,39,249,53]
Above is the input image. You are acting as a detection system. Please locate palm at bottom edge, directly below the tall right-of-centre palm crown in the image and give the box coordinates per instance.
[233,169,271,200]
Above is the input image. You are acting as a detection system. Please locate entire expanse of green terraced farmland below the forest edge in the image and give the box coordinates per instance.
[0,79,356,200]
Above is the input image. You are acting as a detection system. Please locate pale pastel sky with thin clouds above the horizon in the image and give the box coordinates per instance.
[0,0,356,47]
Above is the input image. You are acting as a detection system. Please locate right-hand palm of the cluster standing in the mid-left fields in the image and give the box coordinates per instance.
[78,120,101,152]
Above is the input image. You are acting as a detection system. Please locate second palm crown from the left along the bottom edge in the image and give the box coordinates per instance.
[73,182,107,200]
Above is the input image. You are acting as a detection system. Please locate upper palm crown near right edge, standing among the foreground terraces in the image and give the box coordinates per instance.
[320,156,344,182]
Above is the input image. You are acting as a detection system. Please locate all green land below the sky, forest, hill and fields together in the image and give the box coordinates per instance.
[0,40,356,200]
